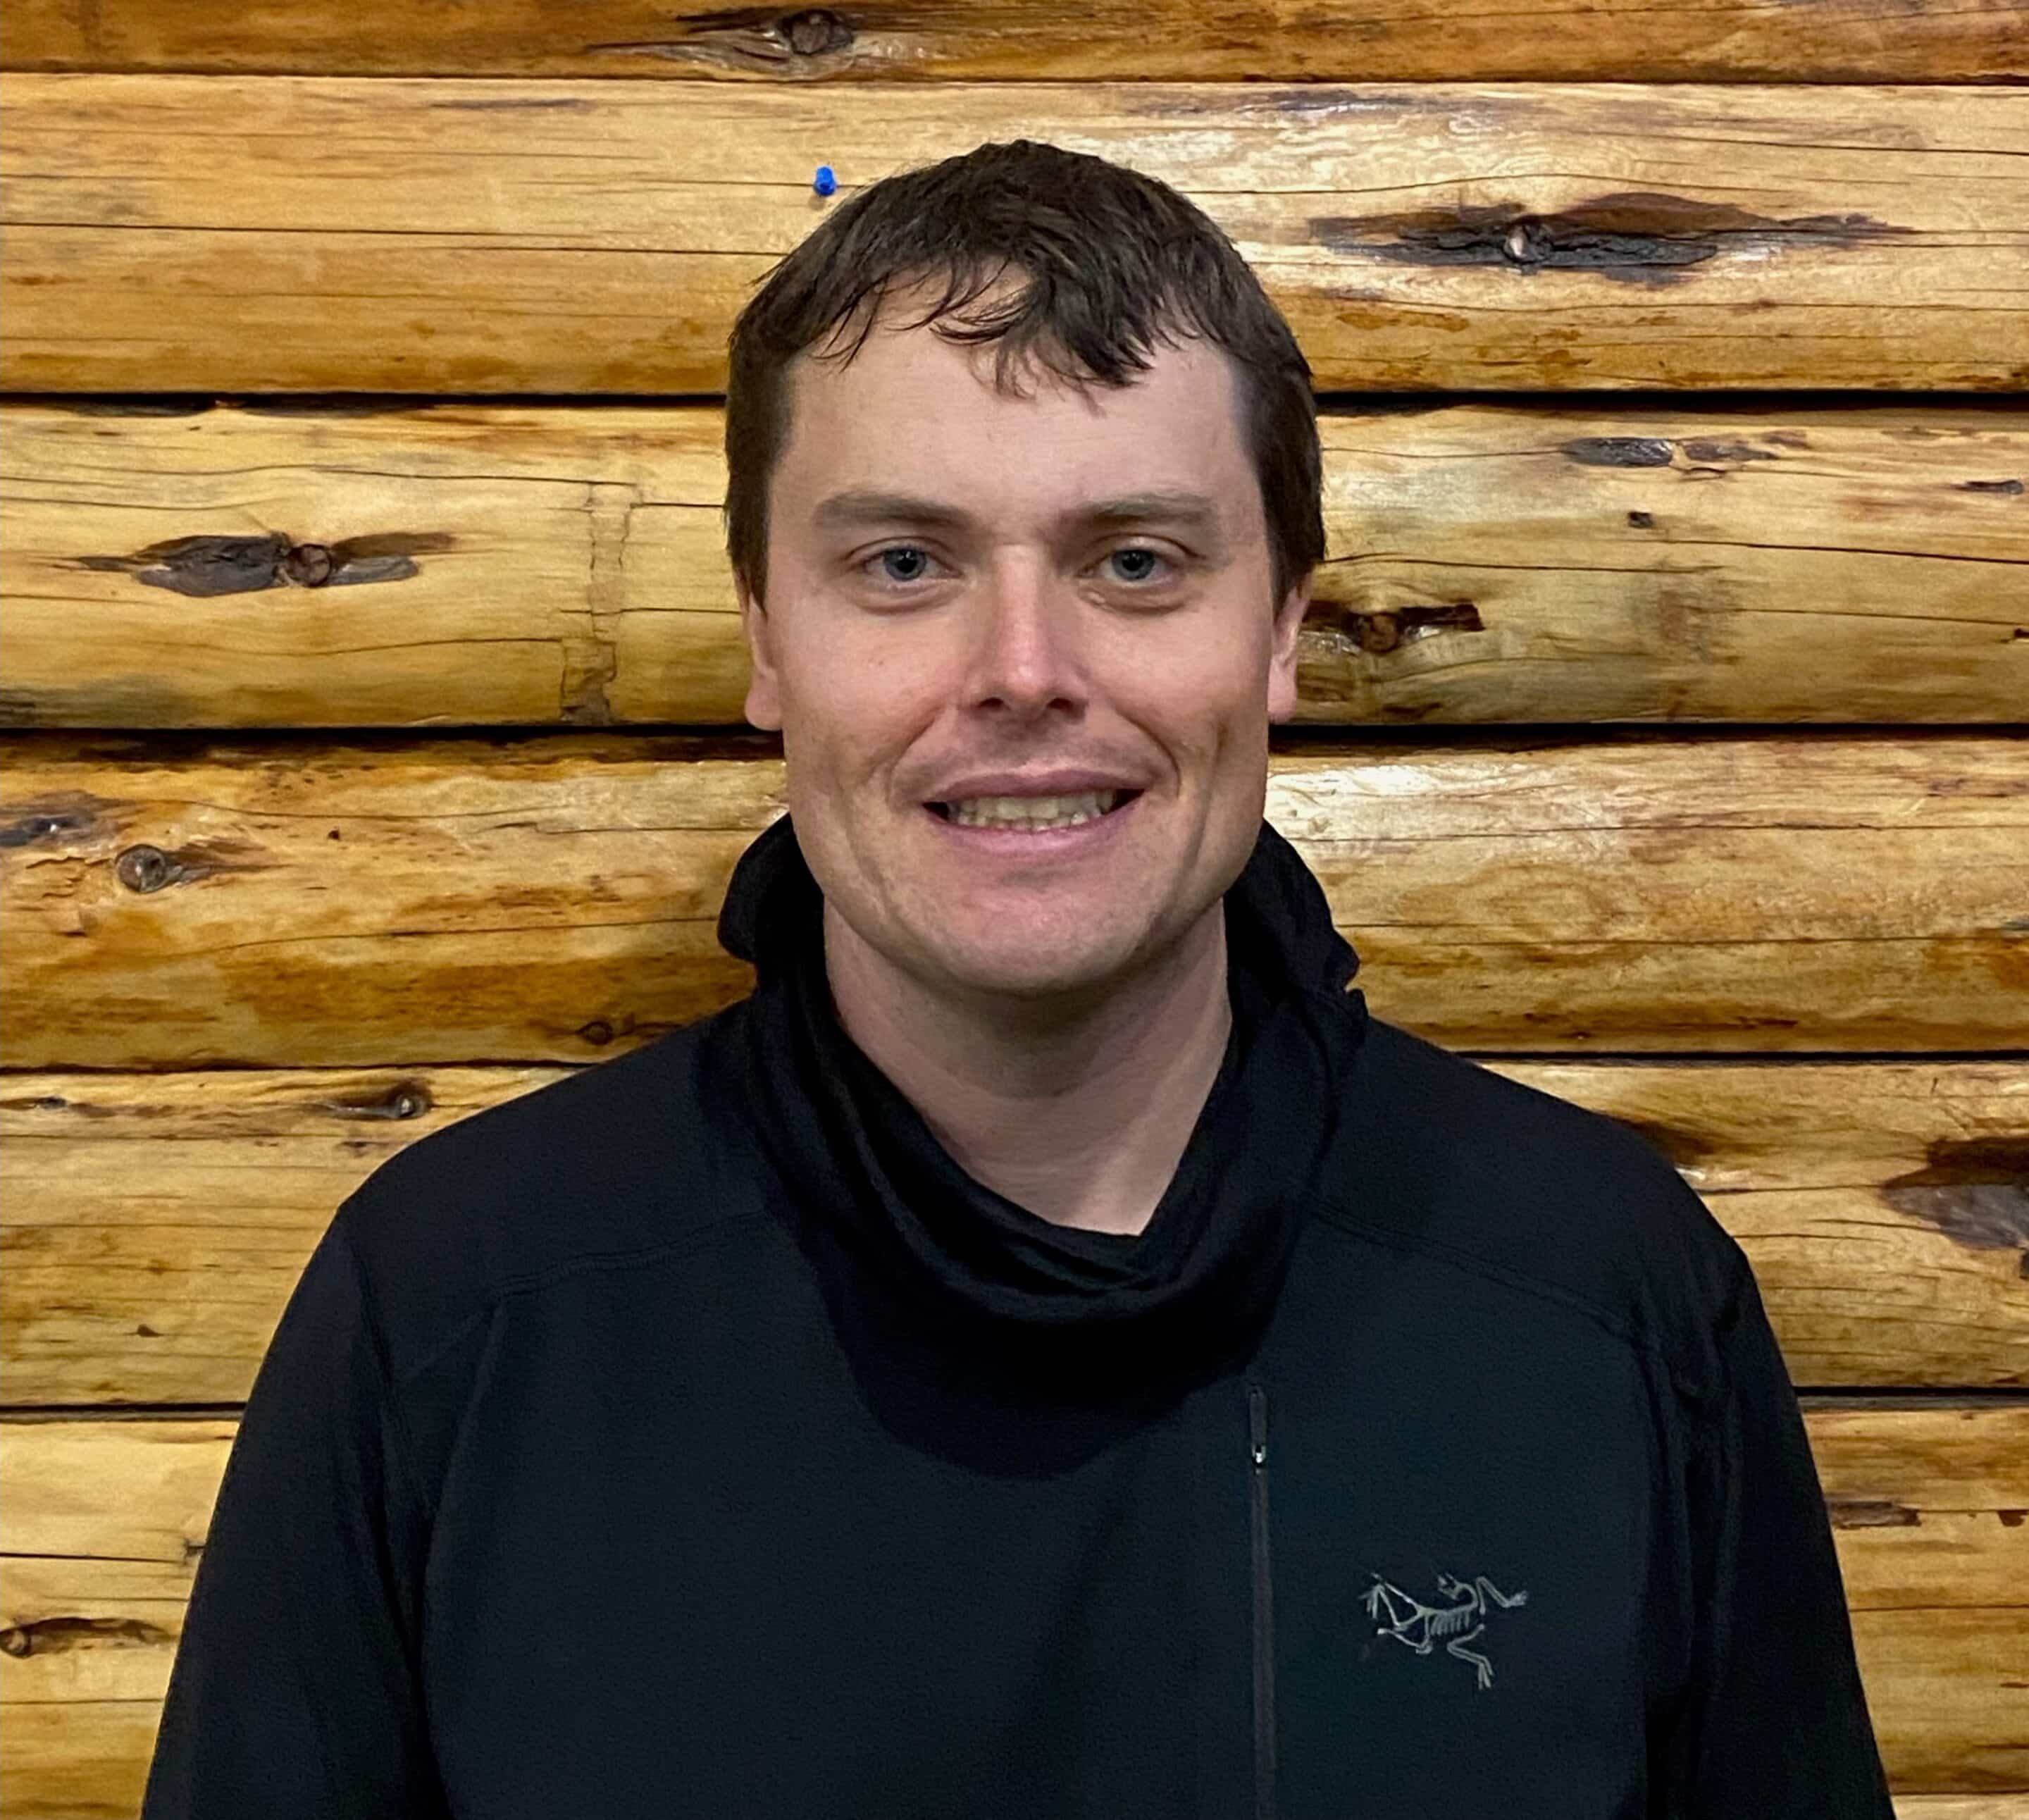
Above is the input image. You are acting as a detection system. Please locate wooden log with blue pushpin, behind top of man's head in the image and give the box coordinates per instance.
[0,75,2029,394]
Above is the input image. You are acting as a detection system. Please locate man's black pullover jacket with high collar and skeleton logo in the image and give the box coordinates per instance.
[144,819,1889,1820]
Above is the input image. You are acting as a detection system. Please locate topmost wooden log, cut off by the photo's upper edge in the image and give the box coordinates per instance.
[6,0,2029,83]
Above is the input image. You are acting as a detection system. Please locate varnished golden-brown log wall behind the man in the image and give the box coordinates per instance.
[0,0,2029,1820]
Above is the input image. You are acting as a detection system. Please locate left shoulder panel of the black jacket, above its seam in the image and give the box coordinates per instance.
[333,1006,761,1378]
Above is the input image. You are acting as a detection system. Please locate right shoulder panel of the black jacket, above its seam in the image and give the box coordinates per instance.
[1327,1019,1753,1386]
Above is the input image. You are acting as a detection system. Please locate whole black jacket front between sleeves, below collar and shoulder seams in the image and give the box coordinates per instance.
[426,1225,1649,1820]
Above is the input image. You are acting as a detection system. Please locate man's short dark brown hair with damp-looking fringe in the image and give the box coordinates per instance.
[724,140,1325,605]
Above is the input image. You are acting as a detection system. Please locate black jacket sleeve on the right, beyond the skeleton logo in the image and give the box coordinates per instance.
[1665,1262,1893,1820]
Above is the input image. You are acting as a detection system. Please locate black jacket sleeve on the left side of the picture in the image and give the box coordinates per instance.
[142,1209,447,1820]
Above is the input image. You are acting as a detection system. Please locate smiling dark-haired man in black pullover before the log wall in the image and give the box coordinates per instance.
[146,142,1889,1820]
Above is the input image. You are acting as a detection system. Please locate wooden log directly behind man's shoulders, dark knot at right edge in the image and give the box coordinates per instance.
[0,1059,2029,1406]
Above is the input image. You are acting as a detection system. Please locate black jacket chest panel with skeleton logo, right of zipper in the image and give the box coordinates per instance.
[1266,1242,1656,1820]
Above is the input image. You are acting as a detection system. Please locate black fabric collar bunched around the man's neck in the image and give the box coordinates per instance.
[719,816,1365,1444]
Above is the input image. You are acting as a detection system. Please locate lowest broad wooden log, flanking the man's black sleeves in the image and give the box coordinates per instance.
[0,1402,2029,1793]
